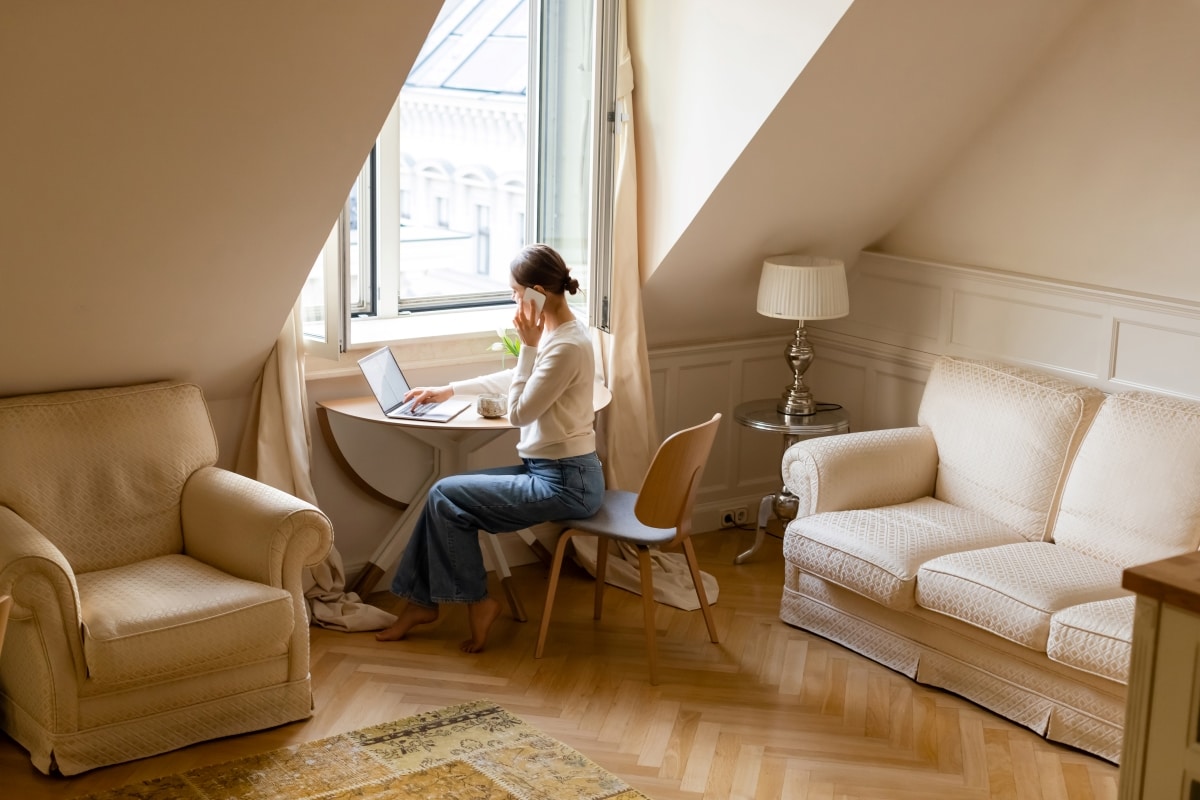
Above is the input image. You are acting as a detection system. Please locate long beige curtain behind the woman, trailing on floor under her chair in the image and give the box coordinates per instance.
[574,0,718,610]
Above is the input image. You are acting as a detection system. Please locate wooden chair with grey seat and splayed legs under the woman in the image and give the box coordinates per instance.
[534,414,721,684]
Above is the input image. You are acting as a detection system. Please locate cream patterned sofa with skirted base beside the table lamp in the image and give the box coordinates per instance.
[780,356,1200,762]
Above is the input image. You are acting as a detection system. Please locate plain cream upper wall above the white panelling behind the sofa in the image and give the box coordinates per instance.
[875,0,1200,300]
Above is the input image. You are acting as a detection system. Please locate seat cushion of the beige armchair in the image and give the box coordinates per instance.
[78,554,294,686]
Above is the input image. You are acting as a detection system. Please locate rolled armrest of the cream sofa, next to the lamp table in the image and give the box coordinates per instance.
[782,427,937,517]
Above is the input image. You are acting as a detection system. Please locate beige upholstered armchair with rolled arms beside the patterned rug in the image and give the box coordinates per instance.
[0,383,332,775]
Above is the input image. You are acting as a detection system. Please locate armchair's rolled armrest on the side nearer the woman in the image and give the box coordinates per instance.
[180,467,334,587]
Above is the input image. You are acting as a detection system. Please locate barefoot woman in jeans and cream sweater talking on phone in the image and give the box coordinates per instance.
[376,245,604,652]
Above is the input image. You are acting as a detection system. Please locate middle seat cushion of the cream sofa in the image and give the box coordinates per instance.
[916,542,1126,652]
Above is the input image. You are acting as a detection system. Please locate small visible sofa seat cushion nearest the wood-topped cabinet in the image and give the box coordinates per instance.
[1046,594,1138,684]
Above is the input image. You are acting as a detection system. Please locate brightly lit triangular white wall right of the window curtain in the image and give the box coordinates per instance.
[628,0,852,275]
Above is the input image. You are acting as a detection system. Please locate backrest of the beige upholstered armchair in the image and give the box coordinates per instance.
[0,383,217,573]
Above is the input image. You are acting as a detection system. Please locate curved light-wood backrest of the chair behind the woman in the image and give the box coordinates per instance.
[634,414,721,541]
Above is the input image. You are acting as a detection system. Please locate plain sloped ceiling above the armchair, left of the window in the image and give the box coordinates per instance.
[0,0,442,399]
